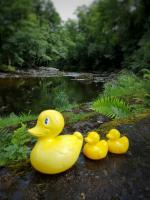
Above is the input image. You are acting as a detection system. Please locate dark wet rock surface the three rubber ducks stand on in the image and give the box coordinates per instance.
[0,118,150,200]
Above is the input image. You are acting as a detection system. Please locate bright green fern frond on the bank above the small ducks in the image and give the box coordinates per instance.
[92,97,131,118]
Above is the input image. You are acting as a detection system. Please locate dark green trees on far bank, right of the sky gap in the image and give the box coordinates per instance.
[61,0,150,71]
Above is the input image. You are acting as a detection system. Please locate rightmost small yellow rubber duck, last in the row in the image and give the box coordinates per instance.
[106,129,129,154]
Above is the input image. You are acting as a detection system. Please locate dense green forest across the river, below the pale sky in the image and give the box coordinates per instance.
[0,0,150,72]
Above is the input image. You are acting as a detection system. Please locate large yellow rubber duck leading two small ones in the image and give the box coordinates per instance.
[28,110,83,174]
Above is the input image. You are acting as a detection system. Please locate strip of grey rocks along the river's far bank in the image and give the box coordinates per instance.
[0,67,118,83]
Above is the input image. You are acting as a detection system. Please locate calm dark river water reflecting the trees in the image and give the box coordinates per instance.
[0,77,103,115]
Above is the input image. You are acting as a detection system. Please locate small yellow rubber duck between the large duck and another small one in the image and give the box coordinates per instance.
[83,131,108,160]
